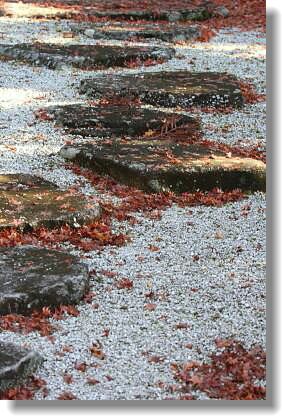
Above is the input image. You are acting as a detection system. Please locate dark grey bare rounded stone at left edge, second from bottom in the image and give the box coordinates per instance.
[0,246,89,315]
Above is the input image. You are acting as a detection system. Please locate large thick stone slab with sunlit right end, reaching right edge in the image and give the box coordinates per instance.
[60,139,265,193]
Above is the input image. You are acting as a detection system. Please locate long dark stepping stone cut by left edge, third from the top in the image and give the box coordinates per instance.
[0,43,175,70]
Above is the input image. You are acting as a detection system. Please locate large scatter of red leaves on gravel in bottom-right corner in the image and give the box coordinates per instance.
[172,340,266,400]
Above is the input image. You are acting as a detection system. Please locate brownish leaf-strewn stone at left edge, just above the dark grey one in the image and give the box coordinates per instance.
[0,174,101,231]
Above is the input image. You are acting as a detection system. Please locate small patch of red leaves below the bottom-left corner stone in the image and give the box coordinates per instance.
[0,376,48,400]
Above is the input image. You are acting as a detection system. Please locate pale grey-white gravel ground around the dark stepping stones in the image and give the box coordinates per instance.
[0,13,266,400]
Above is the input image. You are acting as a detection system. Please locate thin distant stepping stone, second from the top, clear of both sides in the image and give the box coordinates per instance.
[78,23,201,42]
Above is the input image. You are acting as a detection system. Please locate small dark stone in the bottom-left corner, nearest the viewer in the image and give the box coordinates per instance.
[0,341,43,392]
